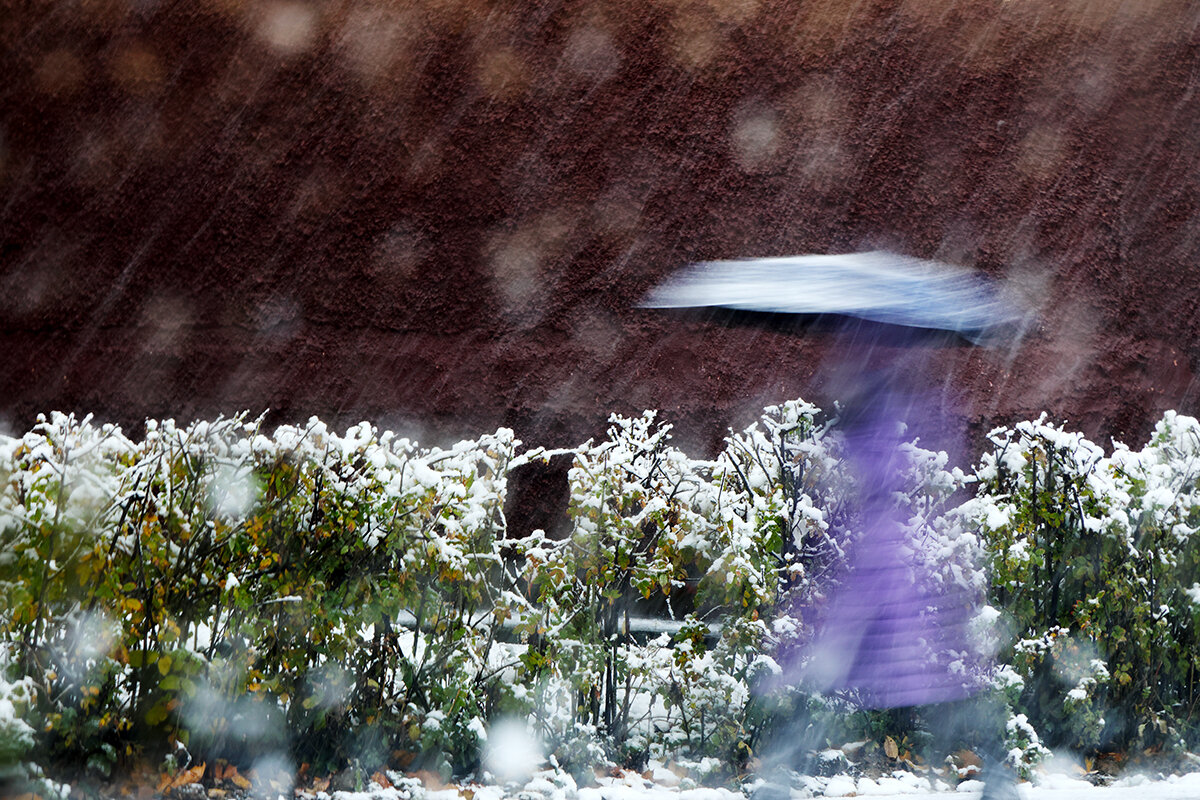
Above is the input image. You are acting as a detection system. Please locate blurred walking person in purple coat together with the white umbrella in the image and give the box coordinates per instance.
[643,252,1026,800]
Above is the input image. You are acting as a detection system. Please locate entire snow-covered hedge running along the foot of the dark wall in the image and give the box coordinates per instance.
[0,401,1200,771]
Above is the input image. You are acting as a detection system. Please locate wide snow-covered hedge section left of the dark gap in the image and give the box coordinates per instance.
[0,415,518,772]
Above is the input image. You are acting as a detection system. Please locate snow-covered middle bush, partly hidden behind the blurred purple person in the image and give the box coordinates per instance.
[522,401,984,770]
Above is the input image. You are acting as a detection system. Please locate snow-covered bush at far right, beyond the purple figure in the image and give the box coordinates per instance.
[964,413,1200,747]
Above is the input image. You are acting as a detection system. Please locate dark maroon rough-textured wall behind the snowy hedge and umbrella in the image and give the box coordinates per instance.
[0,0,1200,462]
